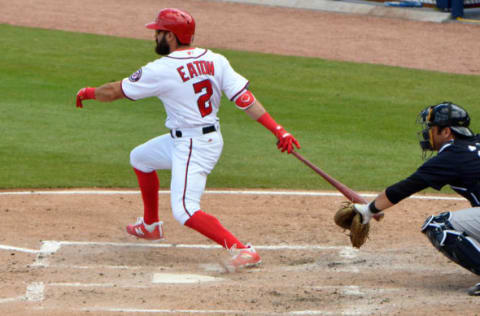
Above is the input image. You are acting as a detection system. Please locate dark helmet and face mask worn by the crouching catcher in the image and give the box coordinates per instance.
[417,102,474,152]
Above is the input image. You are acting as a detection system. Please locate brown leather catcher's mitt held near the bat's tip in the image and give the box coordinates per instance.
[334,202,370,248]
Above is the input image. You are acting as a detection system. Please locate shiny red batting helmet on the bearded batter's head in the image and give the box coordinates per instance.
[146,8,195,44]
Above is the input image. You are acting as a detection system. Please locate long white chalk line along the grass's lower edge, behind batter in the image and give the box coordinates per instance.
[0,190,465,201]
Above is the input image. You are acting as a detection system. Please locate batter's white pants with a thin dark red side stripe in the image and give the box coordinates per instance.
[130,125,223,225]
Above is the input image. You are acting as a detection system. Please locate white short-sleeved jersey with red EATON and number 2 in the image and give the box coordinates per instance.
[122,48,248,129]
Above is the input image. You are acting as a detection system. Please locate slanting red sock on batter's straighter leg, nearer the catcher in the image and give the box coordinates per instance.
[185,210,246,249]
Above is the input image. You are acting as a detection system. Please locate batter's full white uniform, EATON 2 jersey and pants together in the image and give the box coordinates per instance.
[122,48,248,224]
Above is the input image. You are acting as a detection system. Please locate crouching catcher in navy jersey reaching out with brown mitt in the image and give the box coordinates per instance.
[335,102,480,295]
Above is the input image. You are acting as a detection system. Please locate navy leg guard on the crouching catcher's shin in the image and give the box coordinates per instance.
[422,212,480,275]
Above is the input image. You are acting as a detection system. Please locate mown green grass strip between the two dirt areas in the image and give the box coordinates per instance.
[0,25,480,190]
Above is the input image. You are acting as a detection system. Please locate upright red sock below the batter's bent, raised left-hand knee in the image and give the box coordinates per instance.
[133,168,160,225]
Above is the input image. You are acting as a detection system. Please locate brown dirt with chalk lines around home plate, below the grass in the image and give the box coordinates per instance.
[0,192,480,315]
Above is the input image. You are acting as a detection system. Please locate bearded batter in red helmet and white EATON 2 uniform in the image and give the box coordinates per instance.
[77,8,300,269]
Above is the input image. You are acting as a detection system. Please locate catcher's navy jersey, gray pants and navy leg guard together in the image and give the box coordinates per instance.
[385,134,480,275]
